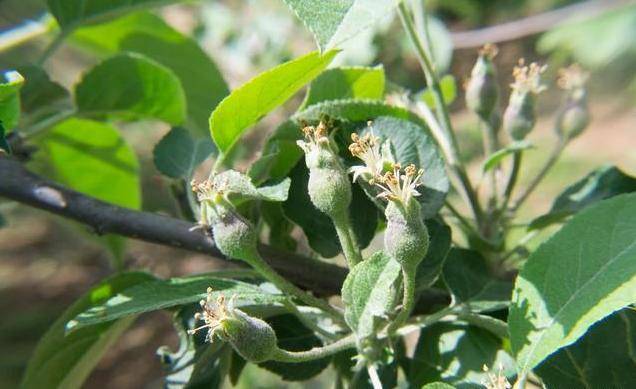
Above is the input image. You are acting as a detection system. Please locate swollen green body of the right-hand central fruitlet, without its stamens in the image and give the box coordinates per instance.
[384,199,429,269]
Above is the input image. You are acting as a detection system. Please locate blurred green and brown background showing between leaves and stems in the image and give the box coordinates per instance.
[0,0,636,388]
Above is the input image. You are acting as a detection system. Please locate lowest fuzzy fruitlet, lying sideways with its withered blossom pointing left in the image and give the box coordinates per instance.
[188,288,278,363]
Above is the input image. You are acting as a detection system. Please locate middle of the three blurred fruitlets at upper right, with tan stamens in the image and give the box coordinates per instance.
[503,59,546,140]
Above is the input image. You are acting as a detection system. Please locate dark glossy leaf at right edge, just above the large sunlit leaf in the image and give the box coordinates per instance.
[529,165,636,229]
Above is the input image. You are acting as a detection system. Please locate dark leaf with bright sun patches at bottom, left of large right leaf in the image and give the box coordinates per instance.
[407,322,515,389]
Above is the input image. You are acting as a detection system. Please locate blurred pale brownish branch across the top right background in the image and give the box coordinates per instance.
[451,0,634,49]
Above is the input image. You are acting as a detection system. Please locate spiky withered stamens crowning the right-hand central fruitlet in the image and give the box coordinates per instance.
[374,163,424,205]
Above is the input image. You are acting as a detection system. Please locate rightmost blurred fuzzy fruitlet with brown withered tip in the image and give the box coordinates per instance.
[555,64,590,139]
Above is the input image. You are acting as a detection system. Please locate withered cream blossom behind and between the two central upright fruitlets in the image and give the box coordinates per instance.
[349,122,395,182]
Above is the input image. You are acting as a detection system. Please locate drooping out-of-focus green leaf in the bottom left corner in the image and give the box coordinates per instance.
[20,272,154,389]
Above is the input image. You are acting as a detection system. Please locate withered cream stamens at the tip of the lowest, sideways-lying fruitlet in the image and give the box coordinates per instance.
[188,288,236,342]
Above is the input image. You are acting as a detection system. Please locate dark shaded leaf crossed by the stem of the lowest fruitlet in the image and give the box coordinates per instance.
[259,314,331,381]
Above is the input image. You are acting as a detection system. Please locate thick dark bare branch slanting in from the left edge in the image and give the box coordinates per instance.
[0,151,347,295]
